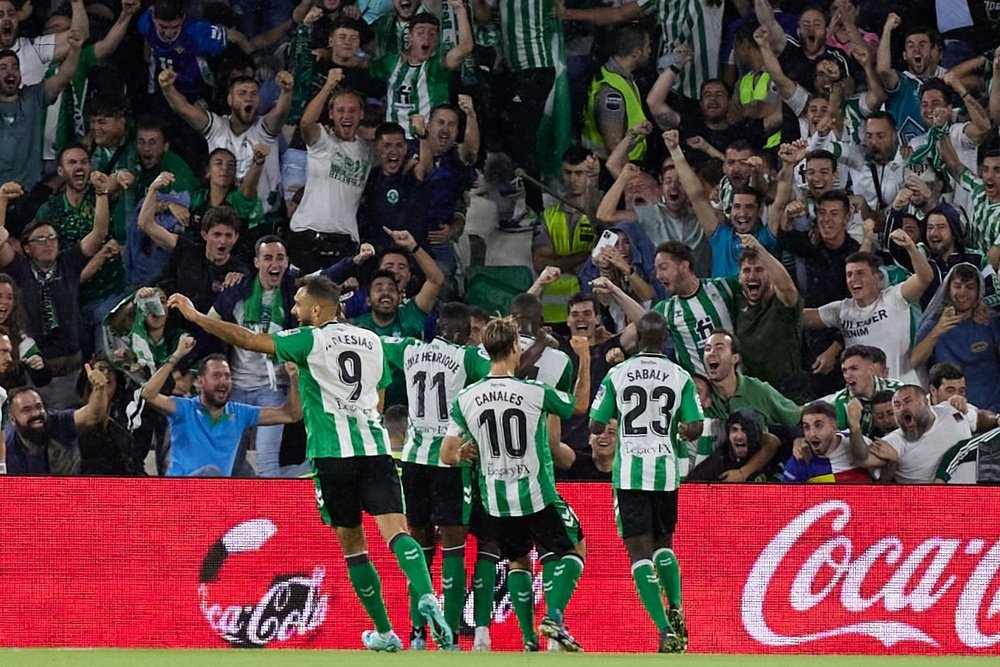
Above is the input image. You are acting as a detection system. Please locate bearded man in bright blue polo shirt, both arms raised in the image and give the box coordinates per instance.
[142,334,302,477]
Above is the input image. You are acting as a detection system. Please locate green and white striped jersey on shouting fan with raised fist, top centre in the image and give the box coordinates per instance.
[368,49,451,139]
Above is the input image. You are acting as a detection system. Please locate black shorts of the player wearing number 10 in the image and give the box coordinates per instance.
[493,498,583,560]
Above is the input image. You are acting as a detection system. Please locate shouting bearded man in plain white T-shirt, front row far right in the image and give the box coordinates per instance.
[884,384,972,484]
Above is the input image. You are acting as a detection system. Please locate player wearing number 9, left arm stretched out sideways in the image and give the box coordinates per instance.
[167,276,454,652]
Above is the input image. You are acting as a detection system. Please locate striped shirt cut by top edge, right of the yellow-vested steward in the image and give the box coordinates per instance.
[639,0,725,100]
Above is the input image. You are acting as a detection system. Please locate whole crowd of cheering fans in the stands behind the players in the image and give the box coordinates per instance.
[0,0,1000,483]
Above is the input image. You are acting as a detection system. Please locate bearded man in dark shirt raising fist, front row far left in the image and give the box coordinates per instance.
[0,360,108,475]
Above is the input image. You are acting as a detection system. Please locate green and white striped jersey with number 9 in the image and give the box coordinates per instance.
[271,322,392,459]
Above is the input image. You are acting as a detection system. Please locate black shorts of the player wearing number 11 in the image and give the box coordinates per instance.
[403,461,472,526]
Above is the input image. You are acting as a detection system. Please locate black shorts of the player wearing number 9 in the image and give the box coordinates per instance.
[313,454,403,528]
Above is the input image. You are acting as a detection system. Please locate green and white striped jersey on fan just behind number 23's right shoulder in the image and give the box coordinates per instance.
[653,278,740,375]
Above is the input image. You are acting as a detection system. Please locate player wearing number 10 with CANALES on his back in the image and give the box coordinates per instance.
[441,317,585,651]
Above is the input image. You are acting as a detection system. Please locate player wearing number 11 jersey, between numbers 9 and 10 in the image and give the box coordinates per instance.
[383,303,495,649]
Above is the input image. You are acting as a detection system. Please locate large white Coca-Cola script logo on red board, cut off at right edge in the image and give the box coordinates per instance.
[741,500,1000,650]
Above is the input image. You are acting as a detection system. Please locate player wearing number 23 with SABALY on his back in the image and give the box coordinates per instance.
[590,312,703,653]
